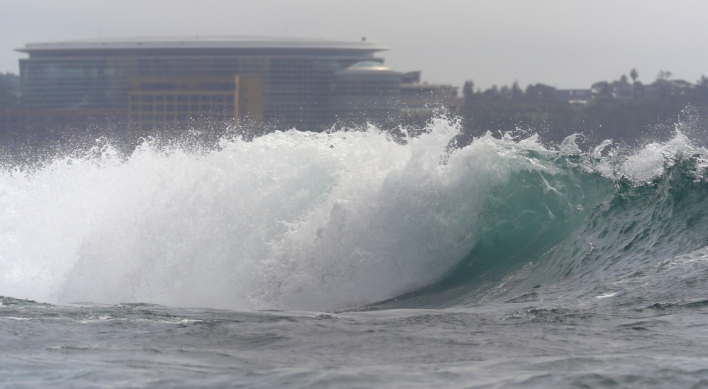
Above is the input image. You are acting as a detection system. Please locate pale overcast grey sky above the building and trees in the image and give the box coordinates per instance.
[0,0,708,88]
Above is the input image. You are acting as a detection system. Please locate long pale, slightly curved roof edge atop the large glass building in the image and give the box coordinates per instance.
[16,36,388,53]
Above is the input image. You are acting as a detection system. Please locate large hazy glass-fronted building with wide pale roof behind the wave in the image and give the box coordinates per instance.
[17,37,386,129]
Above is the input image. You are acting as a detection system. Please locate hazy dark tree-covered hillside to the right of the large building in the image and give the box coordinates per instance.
[458,69,708,144]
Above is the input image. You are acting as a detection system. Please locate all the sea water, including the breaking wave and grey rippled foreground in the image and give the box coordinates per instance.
[0,119,708,388]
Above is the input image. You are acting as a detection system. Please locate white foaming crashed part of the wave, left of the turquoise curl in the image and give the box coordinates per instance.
[0,120,704,310]
